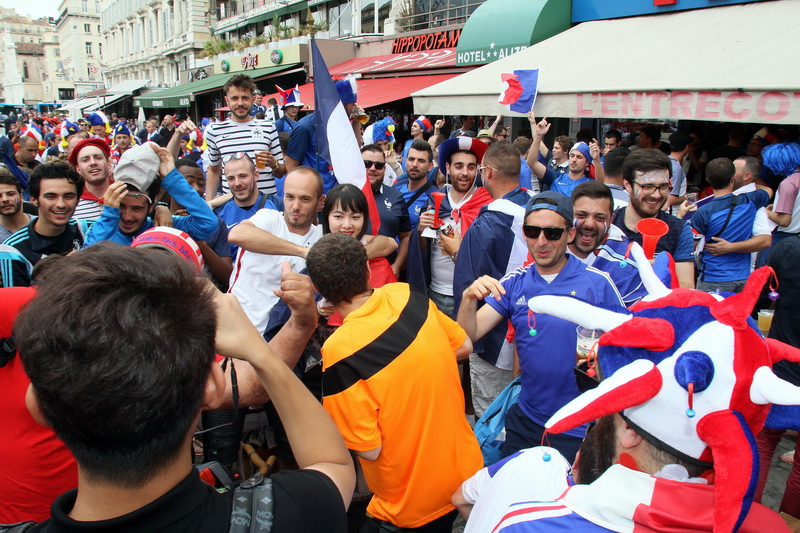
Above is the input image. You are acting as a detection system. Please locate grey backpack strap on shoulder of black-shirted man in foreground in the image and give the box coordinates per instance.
[229,473,275,533]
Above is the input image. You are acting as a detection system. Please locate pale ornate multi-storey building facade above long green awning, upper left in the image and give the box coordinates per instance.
[100,0,211,87]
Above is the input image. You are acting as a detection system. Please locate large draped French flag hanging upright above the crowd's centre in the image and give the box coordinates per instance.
[311,39,381,235]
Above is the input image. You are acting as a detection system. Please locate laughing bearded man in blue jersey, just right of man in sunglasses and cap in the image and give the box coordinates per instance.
[567,181,647,307]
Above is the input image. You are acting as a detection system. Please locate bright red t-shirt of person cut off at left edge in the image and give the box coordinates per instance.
[0,287,78,524]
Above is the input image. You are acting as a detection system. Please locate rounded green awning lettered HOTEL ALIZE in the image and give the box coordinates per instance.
[456,0,572,68]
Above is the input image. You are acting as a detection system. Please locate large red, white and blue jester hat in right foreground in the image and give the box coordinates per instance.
[528,245,800,533]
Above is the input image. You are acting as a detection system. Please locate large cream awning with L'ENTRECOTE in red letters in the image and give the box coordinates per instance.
[412,0,800,124]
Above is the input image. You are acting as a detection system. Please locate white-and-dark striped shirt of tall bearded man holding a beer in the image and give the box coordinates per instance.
[205,118,284,194]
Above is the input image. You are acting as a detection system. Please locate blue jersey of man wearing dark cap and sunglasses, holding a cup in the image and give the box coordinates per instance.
[484,255,623,437]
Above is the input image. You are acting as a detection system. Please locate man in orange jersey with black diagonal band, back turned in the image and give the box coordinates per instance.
[306,234,483,533]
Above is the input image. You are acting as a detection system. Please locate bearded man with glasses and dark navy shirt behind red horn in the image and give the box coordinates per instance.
[612,150,694,289]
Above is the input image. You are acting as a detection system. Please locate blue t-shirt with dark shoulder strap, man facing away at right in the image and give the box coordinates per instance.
[690,189,769,282]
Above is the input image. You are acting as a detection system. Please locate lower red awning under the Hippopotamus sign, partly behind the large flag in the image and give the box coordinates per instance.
[267,74,458,110]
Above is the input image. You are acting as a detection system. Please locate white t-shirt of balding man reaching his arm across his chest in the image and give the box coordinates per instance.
[228,209,322,333]
